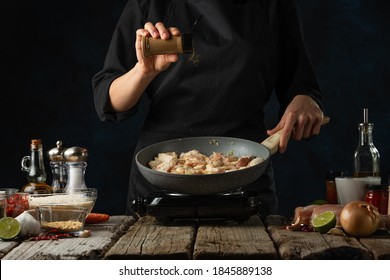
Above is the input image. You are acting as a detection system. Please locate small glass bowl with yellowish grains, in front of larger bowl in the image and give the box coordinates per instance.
[38,205,87,232]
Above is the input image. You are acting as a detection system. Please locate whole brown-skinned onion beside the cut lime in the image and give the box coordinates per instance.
[340,200,381,237]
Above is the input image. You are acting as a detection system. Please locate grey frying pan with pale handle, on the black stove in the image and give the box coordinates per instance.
[135,117,329,195]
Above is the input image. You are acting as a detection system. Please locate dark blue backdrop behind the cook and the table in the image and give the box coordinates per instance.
[0,0,390,219]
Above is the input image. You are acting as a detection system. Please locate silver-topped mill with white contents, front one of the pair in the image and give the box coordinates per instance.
[62,146,88,193]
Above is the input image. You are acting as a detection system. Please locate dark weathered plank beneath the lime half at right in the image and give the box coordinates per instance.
[266,216,373,259]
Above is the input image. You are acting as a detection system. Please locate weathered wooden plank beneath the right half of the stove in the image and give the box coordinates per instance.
[194,216,278,259]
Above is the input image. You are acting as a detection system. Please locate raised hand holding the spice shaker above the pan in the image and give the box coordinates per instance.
[135,22,180,74]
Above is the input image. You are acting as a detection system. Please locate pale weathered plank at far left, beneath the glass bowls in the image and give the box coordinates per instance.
[3,216,134,260]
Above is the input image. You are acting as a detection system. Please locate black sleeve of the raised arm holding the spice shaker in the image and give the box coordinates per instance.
[92,0,144,122]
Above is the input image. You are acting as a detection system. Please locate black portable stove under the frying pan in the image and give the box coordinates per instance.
[133,191,261,222]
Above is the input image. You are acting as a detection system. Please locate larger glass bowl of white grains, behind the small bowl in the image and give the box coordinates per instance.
[29,188,97,215]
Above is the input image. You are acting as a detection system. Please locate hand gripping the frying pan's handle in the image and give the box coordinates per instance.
[267,95,323,153]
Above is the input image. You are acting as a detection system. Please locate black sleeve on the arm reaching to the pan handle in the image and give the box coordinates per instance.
[275,0,323,116]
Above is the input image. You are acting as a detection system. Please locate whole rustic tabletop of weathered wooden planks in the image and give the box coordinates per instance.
[0,216,390,260]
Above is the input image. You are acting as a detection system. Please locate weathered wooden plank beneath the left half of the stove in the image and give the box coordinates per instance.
[106,216,196,259]
